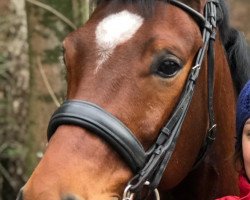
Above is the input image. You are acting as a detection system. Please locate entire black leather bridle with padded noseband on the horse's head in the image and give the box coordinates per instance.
[48,0,220,200]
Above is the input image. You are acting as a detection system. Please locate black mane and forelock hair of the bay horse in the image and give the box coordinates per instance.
[94,0,250,93]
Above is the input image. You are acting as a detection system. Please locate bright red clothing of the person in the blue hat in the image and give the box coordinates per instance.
[216,176,250,200]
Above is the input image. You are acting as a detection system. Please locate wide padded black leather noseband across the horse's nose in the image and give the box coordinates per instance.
[47,100,147,172]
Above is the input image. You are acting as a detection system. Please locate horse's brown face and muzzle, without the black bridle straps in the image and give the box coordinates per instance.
[24,1,202,200]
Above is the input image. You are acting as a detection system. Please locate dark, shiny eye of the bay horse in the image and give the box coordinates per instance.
[155,59,182,78]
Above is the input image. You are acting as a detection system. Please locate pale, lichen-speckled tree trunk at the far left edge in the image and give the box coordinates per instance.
[0,0,29,200]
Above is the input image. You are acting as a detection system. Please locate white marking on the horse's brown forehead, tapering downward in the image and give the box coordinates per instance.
[95,10,143,72]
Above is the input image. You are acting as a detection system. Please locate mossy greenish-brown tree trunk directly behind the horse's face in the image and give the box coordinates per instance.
[23,0,89,175]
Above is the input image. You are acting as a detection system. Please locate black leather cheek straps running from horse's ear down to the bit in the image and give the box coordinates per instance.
[127,0,219,193]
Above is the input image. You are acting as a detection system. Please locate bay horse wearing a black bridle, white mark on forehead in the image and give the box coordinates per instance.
[18,0,249,200]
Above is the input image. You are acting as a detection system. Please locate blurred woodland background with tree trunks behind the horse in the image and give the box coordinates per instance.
[0,0,250,200]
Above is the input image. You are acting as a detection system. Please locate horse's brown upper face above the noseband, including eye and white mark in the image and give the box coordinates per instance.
[64,2,202,146]
